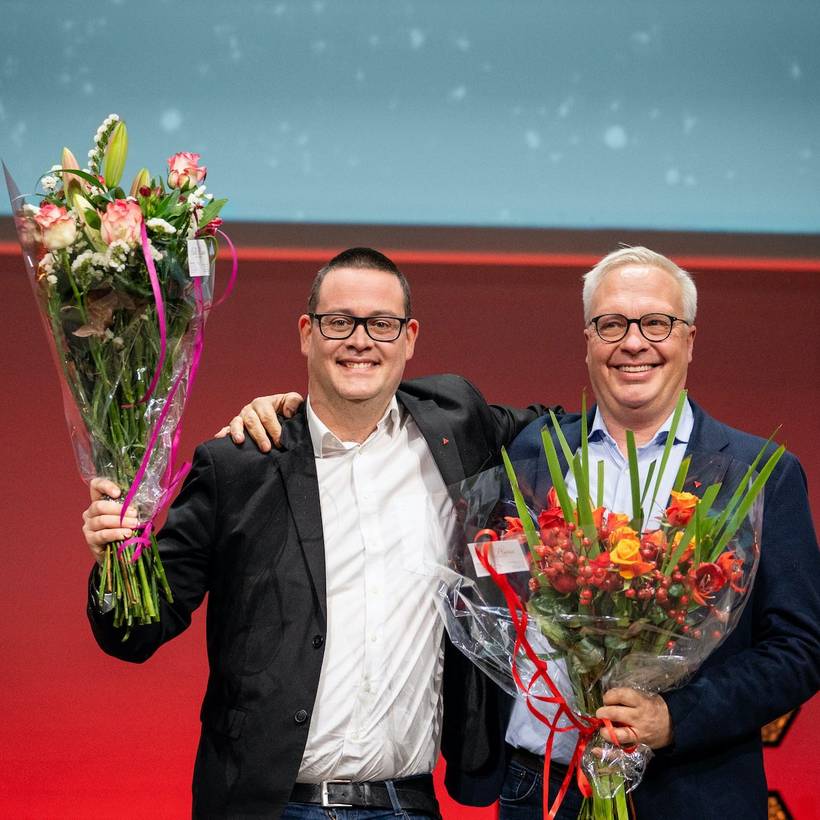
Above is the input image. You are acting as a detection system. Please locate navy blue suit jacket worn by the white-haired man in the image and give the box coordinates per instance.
[454,403,820,820]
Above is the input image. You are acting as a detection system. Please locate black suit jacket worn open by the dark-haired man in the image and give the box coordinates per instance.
[88,376,543,818]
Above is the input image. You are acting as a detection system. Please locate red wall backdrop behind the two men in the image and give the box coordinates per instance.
[0,244,820,820]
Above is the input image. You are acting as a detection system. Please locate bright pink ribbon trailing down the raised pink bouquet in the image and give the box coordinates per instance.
[118,222,239,561]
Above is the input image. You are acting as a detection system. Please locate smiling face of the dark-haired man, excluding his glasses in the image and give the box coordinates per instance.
[299,267,419,424]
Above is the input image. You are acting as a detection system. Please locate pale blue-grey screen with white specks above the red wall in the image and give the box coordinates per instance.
[0,0,820,233]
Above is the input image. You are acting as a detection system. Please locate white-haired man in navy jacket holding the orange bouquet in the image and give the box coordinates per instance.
[490,248,820,820]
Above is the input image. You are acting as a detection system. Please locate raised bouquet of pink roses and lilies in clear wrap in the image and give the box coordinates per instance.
[5,114,236,637]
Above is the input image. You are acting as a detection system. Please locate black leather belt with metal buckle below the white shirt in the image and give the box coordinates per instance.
[290,774,440,817]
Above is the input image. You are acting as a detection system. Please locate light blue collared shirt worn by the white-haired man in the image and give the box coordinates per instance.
[506,401,694,764]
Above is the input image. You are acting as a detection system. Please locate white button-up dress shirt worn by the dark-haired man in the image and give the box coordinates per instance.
[297,397,452,783]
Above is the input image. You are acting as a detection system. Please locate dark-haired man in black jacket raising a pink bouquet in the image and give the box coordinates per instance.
[83,248,543,820]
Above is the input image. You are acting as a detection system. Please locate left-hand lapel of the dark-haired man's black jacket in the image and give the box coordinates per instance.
[277,405,327,622]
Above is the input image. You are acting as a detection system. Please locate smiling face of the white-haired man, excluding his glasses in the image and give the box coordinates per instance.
[584,264,695,429]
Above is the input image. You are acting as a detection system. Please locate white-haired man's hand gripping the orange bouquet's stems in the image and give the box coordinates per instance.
[595,687,672,749]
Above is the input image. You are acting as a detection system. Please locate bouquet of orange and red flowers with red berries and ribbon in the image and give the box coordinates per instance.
[440,393,783,820]
